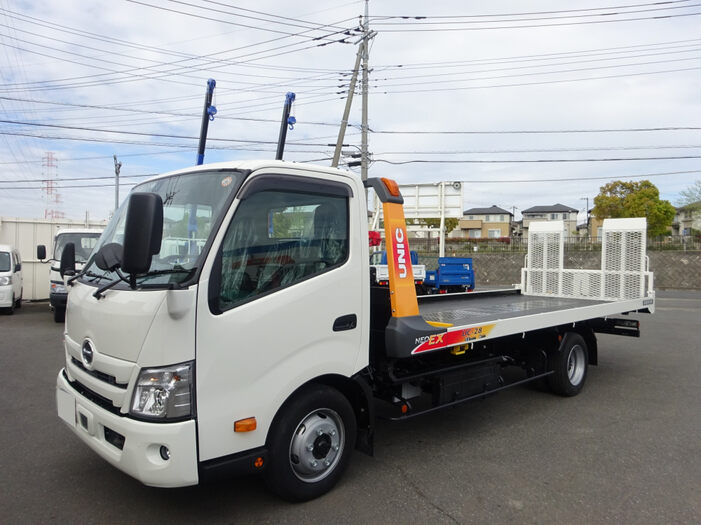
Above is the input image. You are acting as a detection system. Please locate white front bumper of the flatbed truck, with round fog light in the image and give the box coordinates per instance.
[56,370,199,487]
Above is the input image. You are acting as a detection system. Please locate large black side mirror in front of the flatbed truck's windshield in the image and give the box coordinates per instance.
[122,193,163,275]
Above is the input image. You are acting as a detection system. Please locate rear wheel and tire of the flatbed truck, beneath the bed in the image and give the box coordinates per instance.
[547,332,589,397]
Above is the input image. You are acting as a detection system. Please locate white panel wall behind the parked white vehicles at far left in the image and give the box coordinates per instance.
[0,217,107,301]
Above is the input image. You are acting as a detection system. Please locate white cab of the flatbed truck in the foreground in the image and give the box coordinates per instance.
[57,162,370,498]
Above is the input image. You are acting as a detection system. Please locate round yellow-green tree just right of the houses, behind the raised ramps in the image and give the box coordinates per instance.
[593,180,675,237]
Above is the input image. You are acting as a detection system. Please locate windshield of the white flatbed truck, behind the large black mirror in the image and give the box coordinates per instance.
[86,170,242,284]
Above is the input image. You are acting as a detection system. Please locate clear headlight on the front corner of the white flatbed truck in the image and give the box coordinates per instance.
[131,362,193,420]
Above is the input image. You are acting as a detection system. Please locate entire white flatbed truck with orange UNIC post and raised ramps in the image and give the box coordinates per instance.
[56,161,655,501]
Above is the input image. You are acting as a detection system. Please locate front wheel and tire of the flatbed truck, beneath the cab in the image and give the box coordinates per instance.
[265,384,356,502]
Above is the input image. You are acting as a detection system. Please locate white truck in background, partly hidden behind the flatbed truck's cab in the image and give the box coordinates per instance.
[37,228,102,323]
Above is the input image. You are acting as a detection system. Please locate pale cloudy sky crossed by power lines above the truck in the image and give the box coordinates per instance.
[0,0,701,219]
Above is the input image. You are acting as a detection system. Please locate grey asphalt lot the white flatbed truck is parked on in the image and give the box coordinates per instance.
[0,292,701,524]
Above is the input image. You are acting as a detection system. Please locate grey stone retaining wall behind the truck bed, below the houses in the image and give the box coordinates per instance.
[420,251,701,290]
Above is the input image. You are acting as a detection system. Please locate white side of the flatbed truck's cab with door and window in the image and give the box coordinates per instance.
[191,172,369,461]
